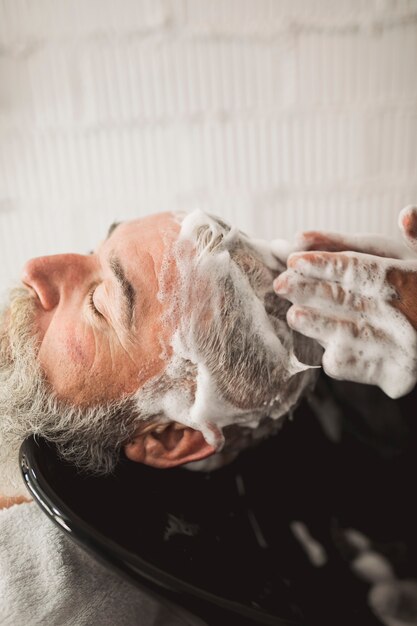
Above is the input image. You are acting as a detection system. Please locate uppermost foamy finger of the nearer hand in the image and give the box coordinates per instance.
[288,252,386,295]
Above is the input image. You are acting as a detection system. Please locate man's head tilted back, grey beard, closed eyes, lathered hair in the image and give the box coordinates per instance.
[0,212,317,491]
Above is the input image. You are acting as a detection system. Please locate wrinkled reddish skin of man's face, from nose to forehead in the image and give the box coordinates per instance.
[22,213,179,405]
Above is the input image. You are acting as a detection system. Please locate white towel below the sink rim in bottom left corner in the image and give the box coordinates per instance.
[0,503,204,626]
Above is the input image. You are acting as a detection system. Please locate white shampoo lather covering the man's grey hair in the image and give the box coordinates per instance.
[138,211,321,450]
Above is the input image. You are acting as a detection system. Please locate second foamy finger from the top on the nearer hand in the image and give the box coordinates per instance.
[274,270,368,312]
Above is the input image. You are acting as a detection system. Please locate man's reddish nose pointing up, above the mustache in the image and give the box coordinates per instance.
[22,254,91,311]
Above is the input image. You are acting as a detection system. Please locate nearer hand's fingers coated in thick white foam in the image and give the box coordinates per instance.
[287,249,417,398]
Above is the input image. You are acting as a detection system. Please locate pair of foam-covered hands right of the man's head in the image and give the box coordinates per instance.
[274,207,417,398]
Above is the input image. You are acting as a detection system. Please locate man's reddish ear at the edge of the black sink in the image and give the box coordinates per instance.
[124,422,216,469]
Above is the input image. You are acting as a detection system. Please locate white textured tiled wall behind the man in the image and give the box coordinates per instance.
[0,0,417,291]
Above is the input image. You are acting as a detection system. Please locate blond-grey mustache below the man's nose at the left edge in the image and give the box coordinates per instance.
[0,287,38,369]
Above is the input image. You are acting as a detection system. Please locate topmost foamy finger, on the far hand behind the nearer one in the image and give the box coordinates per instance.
[294,230,406,259]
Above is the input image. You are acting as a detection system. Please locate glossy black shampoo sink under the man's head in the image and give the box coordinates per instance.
[20,376,417,626]
